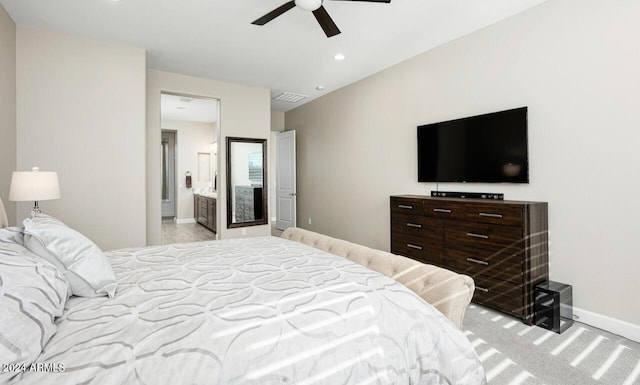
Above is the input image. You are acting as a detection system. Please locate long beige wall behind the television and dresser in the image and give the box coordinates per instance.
[286,0,640,330]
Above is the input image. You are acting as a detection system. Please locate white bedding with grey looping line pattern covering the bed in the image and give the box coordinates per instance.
[14,237,486,385]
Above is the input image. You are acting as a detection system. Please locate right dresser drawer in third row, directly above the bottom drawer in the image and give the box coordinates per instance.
[444,248,523,284]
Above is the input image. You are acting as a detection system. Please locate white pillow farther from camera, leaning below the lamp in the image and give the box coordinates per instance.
[23,214,118,297]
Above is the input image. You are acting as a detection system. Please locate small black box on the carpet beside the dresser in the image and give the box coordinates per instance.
[534,281,573,334]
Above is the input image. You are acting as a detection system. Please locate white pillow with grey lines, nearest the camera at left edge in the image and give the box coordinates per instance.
[0,236,68,384]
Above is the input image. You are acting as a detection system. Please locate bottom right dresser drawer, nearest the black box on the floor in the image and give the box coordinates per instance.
[473,275,525,318]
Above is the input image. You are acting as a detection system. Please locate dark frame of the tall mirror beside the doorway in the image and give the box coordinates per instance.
[226,136,269,229]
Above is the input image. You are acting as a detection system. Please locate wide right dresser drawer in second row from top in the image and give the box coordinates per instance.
[444,221,522,253]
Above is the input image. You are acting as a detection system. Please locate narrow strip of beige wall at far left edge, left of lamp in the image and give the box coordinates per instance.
[0,4,16,226]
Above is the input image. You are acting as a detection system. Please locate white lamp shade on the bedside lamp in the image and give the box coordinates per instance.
[9,167,60,202]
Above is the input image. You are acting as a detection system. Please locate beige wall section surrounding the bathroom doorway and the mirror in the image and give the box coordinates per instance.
[147,69,271,245]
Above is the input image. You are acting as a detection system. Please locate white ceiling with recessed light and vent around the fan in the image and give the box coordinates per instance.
[0,0,546,111]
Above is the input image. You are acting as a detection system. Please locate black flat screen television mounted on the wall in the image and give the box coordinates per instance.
[418,107,529,183]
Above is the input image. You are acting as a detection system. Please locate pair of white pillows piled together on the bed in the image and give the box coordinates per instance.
[0,214,117,384]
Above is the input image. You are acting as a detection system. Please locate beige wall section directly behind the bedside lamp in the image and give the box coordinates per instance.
[17,26,146,249]
